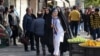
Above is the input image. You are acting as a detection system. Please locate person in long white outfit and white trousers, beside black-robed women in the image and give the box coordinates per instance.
[52,9,64,56]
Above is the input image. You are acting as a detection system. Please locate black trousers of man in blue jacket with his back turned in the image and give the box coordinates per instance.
[35,34,45,53]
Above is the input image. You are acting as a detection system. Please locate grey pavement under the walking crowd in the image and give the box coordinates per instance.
[0,32,90,56]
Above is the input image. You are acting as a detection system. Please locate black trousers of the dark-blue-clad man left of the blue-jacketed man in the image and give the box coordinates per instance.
[24,32,34,51]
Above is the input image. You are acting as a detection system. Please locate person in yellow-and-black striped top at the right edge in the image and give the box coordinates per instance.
[90,8,100,40]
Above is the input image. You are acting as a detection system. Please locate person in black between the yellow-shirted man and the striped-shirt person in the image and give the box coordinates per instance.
[83,7,94,35]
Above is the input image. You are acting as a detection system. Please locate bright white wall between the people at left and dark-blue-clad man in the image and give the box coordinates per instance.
[16,0,28,27]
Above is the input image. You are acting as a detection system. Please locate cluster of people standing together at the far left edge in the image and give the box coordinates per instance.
[0,0,20,46]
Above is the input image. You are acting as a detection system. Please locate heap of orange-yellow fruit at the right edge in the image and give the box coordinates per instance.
[80,40,100,47]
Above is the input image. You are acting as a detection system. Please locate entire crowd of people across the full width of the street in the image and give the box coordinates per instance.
[0,0,100,56]
